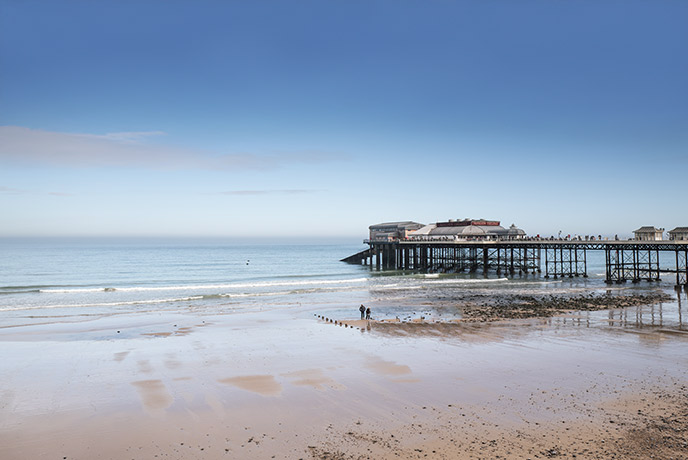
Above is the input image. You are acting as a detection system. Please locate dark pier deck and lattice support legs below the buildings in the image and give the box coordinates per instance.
[343,239,688,291]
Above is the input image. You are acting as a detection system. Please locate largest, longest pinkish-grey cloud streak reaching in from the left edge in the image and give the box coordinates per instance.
[0,126,341,171]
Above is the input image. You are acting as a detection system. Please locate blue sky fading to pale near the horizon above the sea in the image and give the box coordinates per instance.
[0,0,688,240]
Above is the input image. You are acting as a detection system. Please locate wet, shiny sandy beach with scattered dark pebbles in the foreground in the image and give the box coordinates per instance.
[0,294,688,459]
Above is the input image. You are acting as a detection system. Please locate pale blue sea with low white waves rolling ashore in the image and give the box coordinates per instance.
[0,239,686,328]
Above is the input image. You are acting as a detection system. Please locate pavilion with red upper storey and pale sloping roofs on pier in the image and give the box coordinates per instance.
[409,219,526,240]
